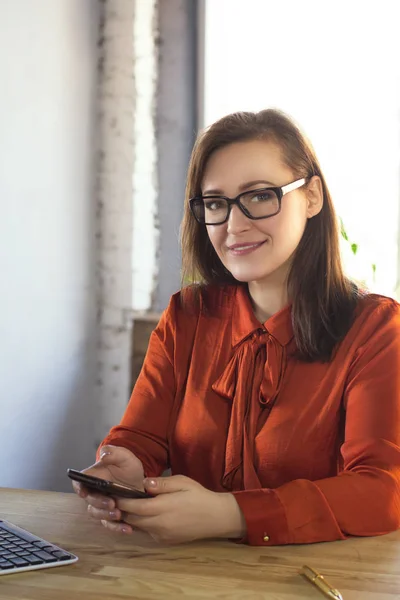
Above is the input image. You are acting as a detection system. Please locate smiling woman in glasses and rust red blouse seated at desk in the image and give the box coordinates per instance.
[74,110,400,545]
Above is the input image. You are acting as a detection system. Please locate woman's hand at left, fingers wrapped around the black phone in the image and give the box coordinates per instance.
[72,446,144,533]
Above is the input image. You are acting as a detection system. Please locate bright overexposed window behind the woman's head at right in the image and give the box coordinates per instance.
[203,0,400,295]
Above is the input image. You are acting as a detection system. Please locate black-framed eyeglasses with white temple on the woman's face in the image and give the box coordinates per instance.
[189,177,306,225]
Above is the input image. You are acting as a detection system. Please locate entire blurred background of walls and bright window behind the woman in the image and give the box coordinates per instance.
[0,0,400,490]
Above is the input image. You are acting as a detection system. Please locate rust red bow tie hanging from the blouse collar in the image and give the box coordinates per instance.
[212,329,286,491]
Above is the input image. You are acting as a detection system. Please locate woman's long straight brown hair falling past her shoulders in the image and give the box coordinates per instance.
[181,109,359,361]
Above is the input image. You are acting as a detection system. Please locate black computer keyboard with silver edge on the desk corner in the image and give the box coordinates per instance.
[0,519,78,575]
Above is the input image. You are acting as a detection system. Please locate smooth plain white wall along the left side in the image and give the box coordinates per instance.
[0,0,98,490]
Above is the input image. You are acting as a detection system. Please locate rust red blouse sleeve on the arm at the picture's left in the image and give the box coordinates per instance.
[98,297,176,477]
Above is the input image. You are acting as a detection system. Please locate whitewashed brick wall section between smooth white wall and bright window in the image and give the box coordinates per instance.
[95,0,197,441]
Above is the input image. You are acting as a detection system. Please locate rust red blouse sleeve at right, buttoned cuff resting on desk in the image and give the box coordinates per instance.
[234,301,400,545]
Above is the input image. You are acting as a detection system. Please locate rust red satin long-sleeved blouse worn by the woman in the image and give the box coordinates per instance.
[102,286,400,545]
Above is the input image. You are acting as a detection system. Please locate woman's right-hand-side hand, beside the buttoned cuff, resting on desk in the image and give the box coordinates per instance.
[103,475,246,544]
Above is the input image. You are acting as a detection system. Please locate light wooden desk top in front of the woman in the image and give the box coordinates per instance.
[0,489,400,600]
